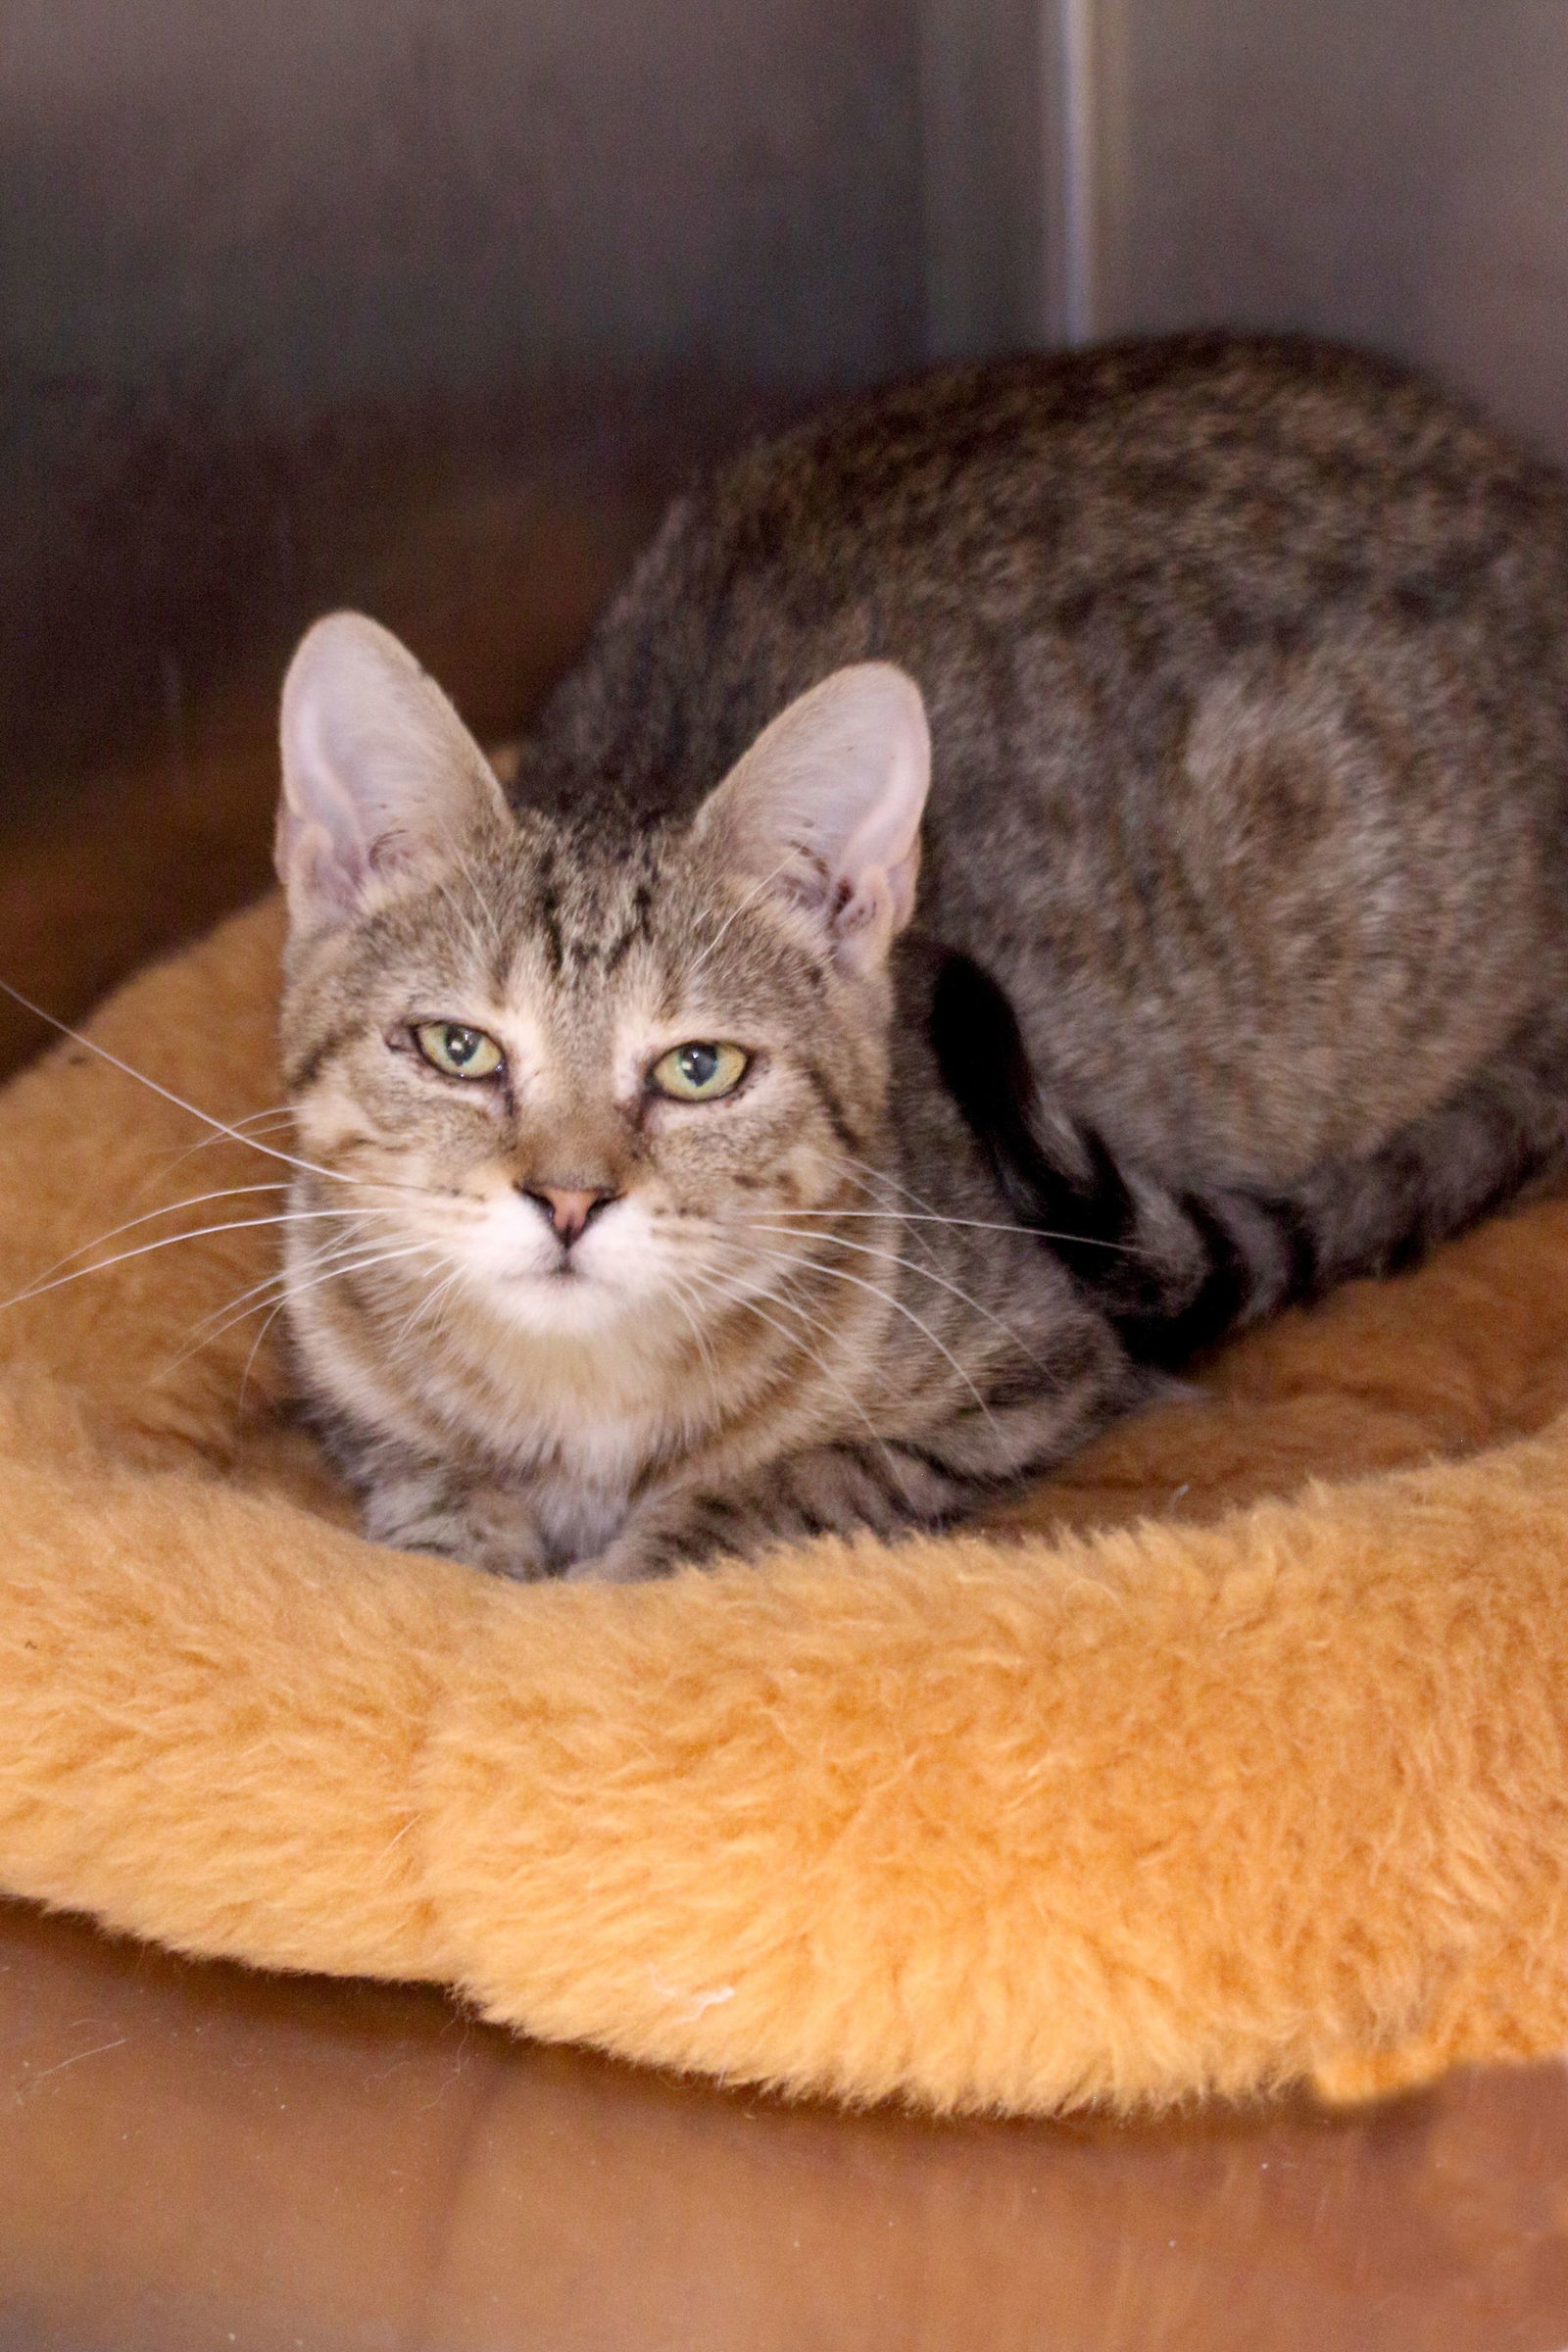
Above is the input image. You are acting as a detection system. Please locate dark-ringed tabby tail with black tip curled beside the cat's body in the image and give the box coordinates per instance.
[931,955,1568,1369]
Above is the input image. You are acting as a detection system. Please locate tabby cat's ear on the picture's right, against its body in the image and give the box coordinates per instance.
[696,661,931,971]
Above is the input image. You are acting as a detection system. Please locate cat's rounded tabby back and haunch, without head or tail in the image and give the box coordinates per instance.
[524,334,1568,1181]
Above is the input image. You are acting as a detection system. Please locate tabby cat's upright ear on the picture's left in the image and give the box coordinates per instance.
[275,612,508,931]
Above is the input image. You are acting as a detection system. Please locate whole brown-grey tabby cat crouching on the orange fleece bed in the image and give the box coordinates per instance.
[277,334,1568,1578]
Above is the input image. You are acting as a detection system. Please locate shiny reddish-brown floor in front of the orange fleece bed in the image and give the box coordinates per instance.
[0,1907,1568,2352]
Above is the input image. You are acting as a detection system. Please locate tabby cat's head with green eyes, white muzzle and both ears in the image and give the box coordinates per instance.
[277,613,929,1346]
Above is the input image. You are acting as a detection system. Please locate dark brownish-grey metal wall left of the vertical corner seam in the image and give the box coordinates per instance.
[0,0,924,807]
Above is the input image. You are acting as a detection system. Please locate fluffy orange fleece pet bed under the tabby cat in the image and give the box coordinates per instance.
[0,906,1568,2112]
